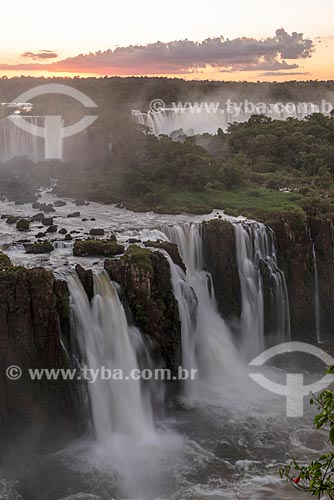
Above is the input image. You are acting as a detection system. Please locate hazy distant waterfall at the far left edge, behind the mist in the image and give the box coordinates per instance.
[0,116,45,163]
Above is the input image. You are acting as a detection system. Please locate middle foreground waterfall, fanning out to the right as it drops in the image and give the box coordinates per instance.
[162,224,243,398]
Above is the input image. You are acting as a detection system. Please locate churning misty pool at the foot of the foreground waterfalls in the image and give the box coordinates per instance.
[0,372,326,500]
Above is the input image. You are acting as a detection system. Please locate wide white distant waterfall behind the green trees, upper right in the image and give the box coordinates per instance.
[132,102,324,136]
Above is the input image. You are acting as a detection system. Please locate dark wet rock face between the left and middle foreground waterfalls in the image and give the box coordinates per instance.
[105,245,182,374]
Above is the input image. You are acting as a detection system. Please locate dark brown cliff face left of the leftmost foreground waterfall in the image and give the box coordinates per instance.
[0,267,80,443]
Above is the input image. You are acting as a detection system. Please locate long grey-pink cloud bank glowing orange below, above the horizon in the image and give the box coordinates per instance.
[0,28,314,75]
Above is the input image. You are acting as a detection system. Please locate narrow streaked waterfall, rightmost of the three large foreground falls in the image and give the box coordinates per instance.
[234,222,290,355]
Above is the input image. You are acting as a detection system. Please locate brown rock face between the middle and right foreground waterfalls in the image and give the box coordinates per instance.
[202,219,241,320]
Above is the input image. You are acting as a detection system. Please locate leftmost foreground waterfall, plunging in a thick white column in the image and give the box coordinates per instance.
[67,271,154,443]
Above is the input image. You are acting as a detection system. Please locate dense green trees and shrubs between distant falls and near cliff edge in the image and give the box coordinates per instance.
[52,114,334,223]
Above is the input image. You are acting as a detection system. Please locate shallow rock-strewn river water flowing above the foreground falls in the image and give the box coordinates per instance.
[0,191,229,269]
